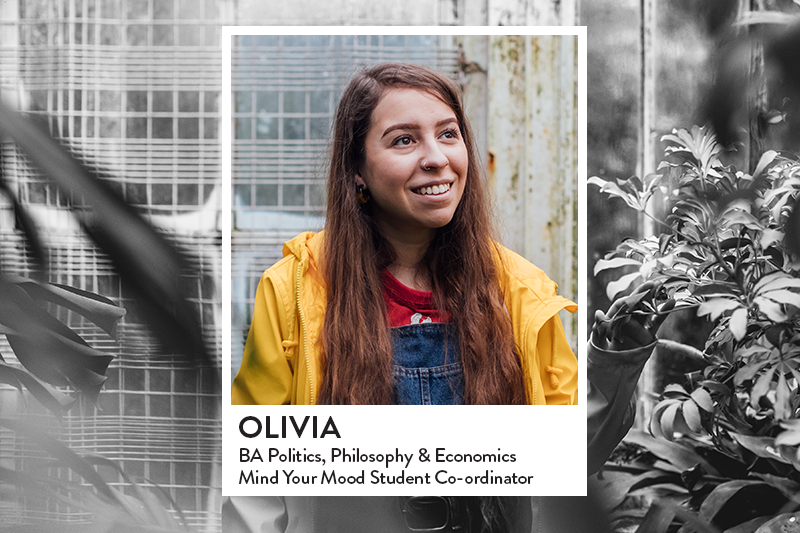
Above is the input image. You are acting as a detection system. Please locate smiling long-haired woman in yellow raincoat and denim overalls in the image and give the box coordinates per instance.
[232,64,577,404]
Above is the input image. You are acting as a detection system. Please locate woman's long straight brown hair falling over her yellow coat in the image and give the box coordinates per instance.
[319,64,525,404]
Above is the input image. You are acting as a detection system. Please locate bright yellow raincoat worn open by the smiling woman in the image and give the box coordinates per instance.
[231,232,578,405]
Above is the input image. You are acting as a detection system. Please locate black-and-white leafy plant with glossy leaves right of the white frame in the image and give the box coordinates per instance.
[589,127,800,532]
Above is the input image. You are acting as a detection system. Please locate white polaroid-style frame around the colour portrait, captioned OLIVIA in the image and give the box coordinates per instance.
[220,26,588,496]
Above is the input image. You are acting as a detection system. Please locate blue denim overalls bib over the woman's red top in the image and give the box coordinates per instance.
[390,322,464,405]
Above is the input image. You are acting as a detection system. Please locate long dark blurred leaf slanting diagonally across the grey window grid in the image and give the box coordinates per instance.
[0,104,216,386]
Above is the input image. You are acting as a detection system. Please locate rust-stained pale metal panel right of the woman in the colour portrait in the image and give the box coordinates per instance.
[488,36,577,348]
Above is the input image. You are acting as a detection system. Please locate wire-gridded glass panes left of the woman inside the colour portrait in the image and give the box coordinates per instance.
[231,35,458,375]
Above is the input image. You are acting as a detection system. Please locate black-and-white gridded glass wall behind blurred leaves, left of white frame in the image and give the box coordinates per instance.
[0,0,223,531]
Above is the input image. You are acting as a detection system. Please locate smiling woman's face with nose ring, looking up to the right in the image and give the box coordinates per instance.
[356,88,469,238]
